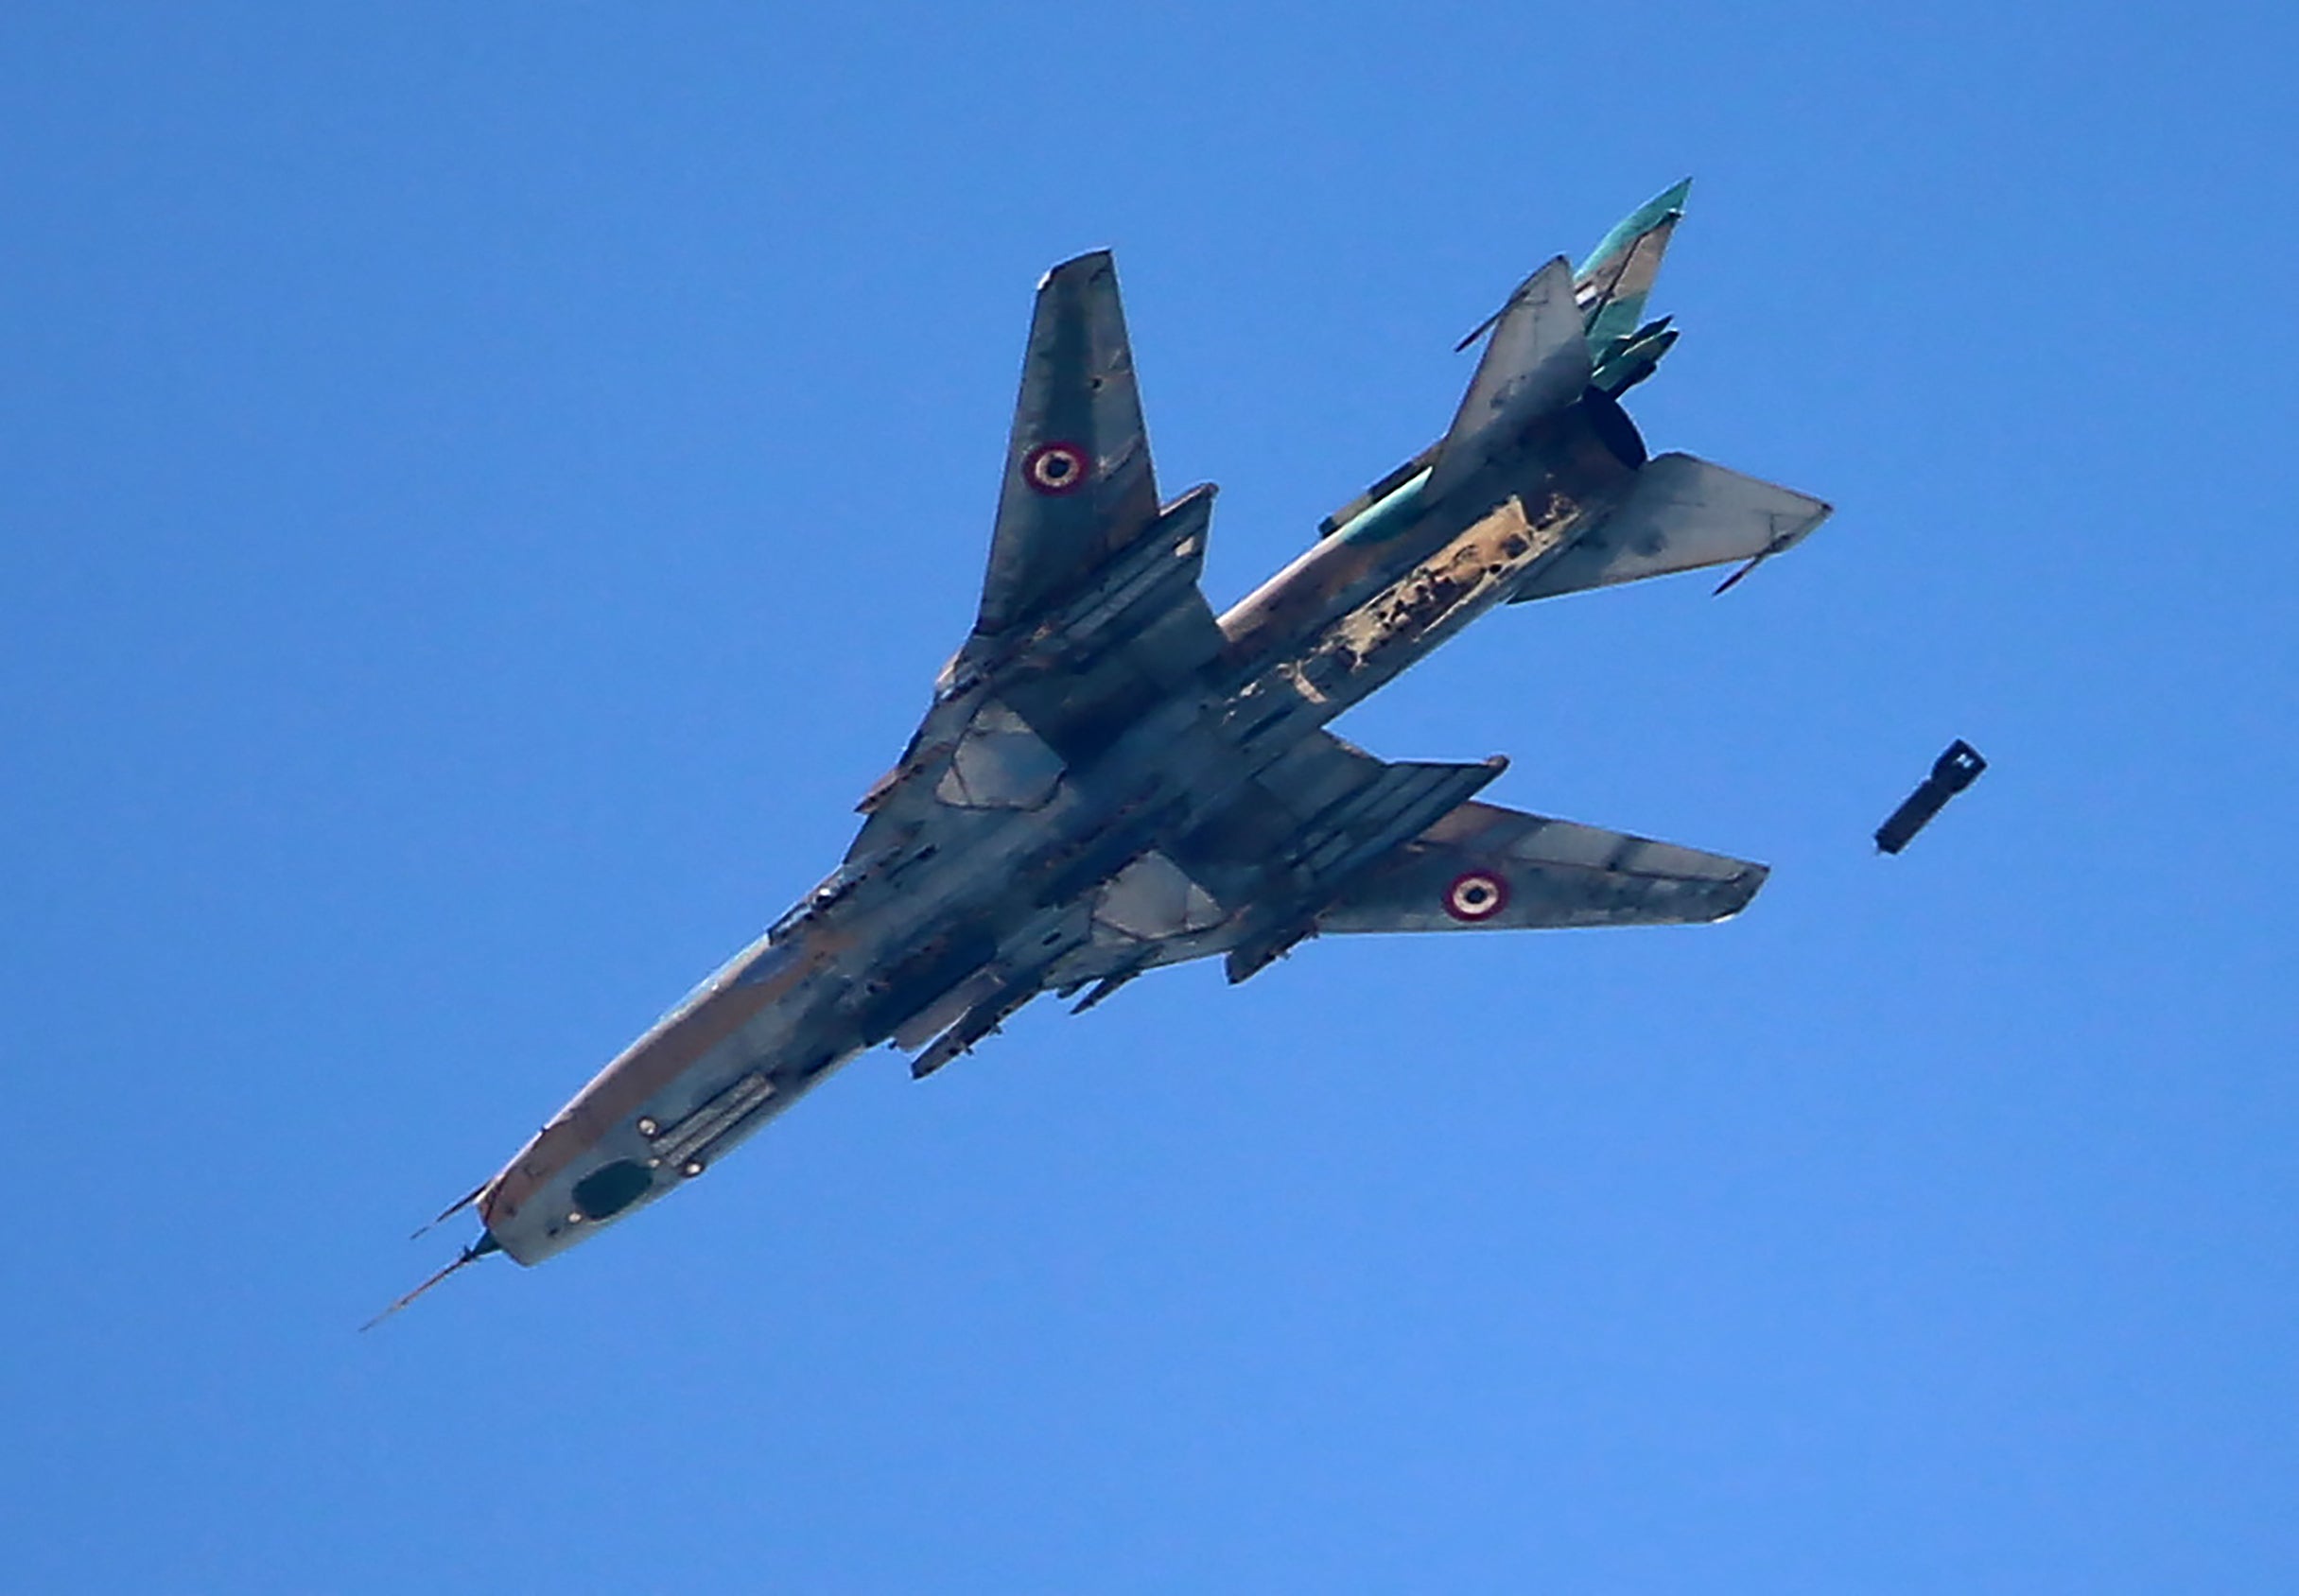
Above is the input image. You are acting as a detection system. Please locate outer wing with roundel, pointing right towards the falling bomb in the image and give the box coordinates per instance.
[1317,800,1768,934]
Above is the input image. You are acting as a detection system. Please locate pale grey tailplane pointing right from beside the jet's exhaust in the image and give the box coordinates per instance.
[1510,456,1830,605]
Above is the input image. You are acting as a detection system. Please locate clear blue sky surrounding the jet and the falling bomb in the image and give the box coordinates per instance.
[0,0,2299,1594]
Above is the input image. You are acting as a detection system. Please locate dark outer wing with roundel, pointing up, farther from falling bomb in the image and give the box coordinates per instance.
[975,251,1158,637]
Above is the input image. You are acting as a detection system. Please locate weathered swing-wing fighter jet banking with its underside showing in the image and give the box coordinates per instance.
[391,184,1830,1296]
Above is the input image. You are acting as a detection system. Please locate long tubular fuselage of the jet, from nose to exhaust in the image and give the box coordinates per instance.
[480,390,1644,1262]
